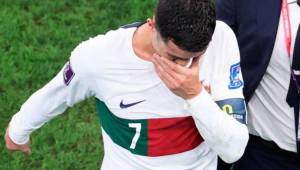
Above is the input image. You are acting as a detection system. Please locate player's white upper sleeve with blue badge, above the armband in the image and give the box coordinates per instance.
[201,21,243,99]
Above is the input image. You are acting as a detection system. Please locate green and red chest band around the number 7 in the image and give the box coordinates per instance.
[96,100,203,157]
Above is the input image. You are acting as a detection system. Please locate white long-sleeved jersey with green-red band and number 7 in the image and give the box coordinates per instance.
[9,21,248,170]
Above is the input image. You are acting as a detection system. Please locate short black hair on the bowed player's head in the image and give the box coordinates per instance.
[154,0,216,52]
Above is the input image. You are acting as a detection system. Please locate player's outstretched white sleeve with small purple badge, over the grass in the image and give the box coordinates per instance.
[9,53,93,144]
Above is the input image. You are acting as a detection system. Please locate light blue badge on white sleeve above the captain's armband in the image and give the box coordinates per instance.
[228,63,244,89]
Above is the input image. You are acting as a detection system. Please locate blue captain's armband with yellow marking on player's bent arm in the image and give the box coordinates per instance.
[216,98,247,124]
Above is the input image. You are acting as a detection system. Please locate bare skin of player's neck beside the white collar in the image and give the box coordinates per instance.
[132,23,155,61]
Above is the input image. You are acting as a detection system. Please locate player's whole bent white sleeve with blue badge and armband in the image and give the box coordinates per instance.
[186,23,249,163]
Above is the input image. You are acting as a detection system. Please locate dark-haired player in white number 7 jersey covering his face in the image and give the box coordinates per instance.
[5,0,248,170]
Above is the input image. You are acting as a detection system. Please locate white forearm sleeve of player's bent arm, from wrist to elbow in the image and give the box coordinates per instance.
[187,89,249,163]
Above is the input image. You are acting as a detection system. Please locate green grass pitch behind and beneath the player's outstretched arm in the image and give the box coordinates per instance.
[0,0,156,170]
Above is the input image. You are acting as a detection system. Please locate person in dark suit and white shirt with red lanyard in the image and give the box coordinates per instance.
[216,0,300,170]
